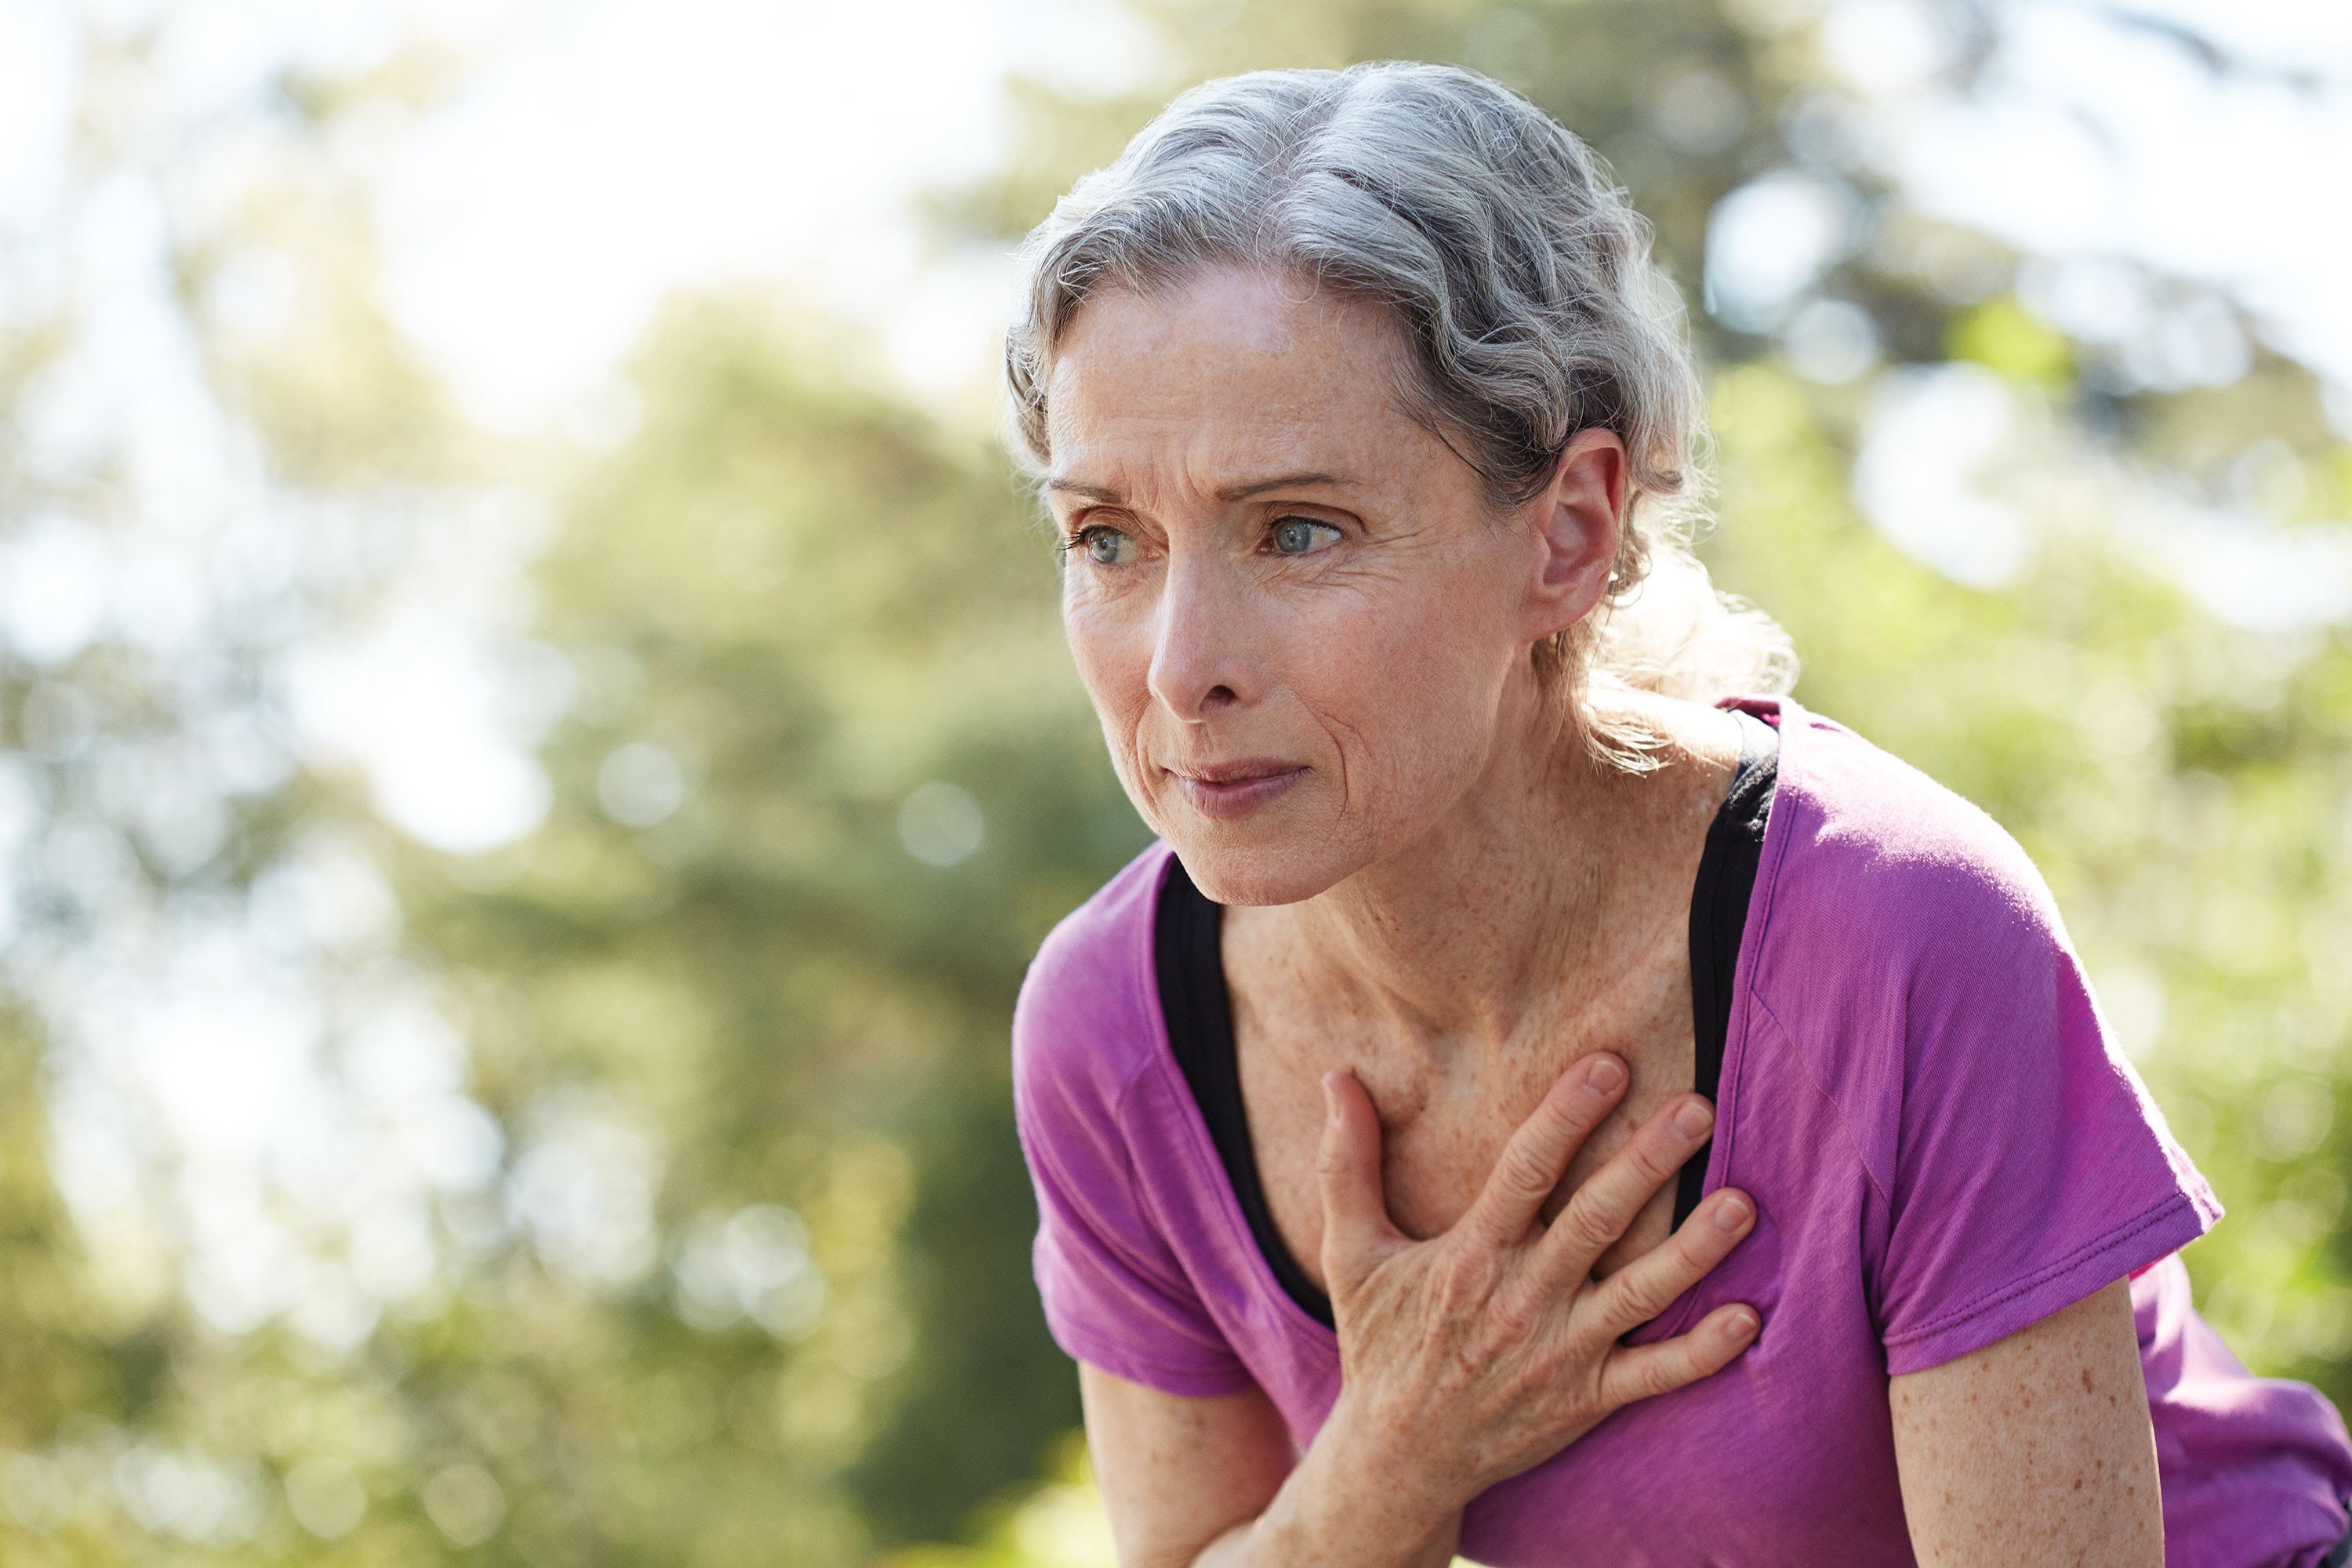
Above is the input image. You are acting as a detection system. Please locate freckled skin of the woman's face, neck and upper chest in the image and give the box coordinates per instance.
[1049,275,1738,1286]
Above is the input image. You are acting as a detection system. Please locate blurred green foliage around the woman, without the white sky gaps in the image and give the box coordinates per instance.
[0,0,2352,1568]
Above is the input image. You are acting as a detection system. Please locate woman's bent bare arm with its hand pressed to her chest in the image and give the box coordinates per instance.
[1082,1058,1757,1568]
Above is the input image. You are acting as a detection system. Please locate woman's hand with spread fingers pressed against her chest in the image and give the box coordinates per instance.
[1317,1053,1757,1519]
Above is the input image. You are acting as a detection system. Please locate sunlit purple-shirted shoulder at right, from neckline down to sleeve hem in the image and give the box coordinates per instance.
[1757,715,2220,1375]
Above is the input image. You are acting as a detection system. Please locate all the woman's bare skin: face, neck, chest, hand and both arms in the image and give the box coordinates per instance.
[1047,270,2161,1568]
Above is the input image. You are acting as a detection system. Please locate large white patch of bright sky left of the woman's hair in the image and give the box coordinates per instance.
[386,0,1117,423]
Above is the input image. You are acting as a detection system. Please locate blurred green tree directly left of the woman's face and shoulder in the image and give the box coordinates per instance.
[388,301,1143,1561]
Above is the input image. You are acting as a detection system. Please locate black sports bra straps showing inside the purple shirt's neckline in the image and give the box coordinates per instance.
[1152,708,1780,1328]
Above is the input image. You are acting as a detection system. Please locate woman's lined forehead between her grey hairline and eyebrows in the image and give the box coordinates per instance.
[1047,268,1444,485]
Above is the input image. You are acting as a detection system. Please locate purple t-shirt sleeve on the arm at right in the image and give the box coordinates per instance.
[1877,818,2220,1375]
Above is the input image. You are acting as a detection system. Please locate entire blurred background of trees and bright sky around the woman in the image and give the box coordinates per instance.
[0,0,2352,1568]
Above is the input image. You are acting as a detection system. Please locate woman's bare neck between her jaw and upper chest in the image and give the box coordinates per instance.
[1270,684,1682,1065]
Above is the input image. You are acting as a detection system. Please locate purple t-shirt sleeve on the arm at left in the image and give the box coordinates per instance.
[1014,926,1254,1396]
